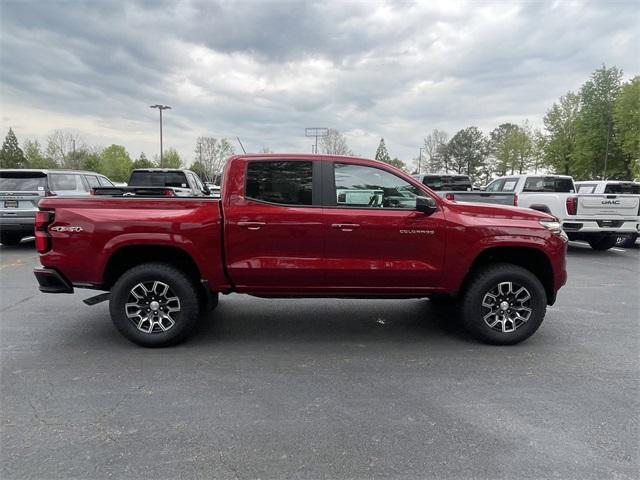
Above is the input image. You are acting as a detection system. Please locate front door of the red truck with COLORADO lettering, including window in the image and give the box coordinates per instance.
[323,161,445,294]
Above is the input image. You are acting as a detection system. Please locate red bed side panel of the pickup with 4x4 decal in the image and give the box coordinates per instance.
[39,197,227,288]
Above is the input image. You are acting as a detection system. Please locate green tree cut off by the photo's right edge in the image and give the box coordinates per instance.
[613,77,640,180]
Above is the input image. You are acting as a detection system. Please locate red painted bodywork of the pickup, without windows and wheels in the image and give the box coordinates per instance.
[35,155,566,296]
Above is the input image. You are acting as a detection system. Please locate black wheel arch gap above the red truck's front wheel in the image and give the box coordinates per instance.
[461,246,556,305]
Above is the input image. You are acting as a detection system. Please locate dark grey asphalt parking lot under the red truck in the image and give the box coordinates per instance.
[0,241,640,480]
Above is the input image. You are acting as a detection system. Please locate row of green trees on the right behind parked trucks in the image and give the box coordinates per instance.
[414,66,640,184]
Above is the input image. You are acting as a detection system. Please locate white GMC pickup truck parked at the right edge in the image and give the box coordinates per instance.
[486,175,640,250]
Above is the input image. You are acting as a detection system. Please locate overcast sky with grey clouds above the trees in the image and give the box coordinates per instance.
[0,0,640,162]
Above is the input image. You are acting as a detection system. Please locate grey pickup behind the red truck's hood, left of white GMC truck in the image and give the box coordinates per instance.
[413,173,518,206]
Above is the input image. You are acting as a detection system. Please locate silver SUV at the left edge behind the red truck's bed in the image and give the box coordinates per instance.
[0,169,113,245]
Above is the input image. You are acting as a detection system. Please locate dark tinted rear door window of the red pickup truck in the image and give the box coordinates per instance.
[246,161,313,205]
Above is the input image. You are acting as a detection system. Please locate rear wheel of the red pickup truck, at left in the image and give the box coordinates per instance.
[109,263,200,347]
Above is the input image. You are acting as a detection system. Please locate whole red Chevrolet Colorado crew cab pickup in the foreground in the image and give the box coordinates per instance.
[35,154,567,347]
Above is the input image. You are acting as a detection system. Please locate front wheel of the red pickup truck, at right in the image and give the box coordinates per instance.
[462,263,547,345]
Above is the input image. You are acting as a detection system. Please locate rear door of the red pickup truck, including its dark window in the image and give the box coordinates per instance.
[224,159,324,293]
